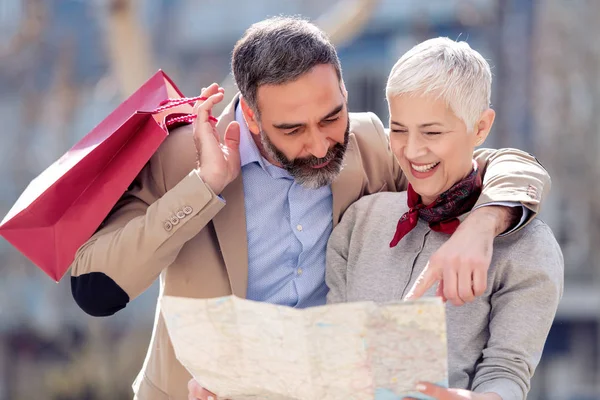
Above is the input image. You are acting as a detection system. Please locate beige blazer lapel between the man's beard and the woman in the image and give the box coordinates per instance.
[331,133,364,228]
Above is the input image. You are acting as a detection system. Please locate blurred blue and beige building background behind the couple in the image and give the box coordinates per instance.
[0,0,600,400]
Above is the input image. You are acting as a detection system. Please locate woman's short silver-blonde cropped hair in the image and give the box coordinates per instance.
[386,37,492,132]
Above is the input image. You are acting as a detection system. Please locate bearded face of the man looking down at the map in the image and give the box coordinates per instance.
[244,65,350,189]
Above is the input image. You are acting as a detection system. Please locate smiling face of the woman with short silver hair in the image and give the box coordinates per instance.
[389,94,494,205]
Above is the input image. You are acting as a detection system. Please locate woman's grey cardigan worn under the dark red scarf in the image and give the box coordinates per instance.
[326,192,564,400]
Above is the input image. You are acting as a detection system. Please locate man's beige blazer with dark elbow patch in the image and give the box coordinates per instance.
[71,97,550,400]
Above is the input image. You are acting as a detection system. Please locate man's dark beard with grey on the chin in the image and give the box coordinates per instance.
[260,118,350,189]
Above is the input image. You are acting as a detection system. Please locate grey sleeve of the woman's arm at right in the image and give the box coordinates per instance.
[472,224,564,399]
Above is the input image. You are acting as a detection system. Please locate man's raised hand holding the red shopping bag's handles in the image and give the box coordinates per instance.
[194,83,241,195]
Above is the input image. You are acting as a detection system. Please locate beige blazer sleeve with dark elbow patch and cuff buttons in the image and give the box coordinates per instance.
[71,139,224,316]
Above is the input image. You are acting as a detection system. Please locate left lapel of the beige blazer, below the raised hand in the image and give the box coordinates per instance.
[212,96,248,298]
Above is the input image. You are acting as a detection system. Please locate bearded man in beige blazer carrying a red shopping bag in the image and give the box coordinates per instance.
[71,18,549,400]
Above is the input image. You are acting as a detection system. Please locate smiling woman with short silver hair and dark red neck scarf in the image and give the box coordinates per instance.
[326,38,563,400]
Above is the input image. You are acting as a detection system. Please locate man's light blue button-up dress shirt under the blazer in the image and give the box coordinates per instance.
[236,106,333,308]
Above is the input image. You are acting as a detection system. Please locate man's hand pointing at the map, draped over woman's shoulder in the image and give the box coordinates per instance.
[405,206,513,306]
